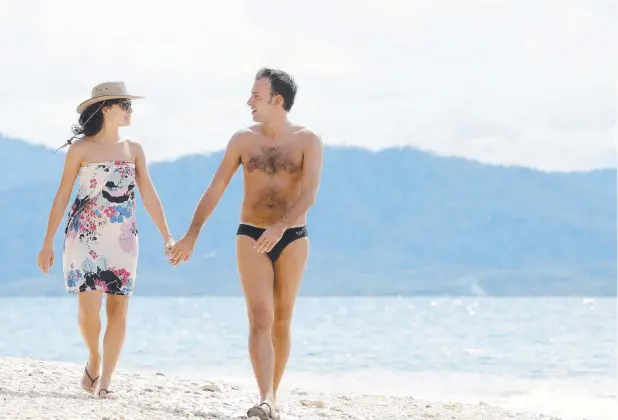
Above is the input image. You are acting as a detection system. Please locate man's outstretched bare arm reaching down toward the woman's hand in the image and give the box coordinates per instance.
[185,132,243,240]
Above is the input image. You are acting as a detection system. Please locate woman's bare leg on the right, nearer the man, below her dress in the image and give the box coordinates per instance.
[99,294,129,397]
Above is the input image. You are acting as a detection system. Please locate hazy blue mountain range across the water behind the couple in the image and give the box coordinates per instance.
[0,135,617,296]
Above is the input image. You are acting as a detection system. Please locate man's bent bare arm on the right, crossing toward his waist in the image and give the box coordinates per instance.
[275,133,323,229]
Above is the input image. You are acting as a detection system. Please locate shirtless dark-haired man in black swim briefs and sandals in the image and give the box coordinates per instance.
[170,68,323,419]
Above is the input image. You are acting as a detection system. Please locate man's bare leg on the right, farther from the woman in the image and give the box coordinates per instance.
[272,237,309,398]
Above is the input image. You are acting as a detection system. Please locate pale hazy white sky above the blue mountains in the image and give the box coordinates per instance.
[0,0,617,170]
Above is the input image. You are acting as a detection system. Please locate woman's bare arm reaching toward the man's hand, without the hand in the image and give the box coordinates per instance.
[131,141,172,243]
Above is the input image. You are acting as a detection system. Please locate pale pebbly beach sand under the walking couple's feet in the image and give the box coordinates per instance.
[0,358,552,420]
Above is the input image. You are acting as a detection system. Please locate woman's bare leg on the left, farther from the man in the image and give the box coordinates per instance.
[77,290,103,392]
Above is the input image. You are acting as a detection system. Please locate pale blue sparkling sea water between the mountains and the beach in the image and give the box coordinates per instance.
[0,297,618,420]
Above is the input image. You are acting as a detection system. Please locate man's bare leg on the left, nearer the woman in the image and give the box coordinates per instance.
[236,235,275,410]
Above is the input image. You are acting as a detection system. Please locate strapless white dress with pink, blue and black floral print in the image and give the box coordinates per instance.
[62,161,139,295]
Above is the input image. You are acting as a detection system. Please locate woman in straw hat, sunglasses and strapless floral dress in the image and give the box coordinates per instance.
[38,82,173,398]
